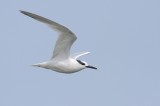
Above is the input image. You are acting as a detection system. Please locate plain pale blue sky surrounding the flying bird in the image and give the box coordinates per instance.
[0,0,160,106]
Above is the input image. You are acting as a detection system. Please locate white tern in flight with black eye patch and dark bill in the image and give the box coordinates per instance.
[20,10,97,73]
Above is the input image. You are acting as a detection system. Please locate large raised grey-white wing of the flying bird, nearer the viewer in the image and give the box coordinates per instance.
[21,11,77,59]
